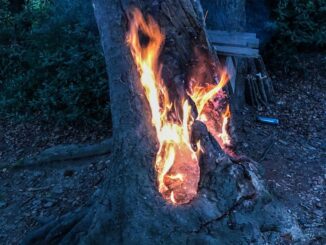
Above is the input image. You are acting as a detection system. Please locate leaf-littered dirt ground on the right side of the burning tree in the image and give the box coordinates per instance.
[238,54,326,244]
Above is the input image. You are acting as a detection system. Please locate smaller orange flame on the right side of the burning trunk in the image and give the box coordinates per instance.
[189,49,235,155]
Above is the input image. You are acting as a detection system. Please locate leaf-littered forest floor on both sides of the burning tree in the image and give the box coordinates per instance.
[0,54,326,244]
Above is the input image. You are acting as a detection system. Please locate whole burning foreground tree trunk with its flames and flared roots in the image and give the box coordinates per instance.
[26,0,297,244]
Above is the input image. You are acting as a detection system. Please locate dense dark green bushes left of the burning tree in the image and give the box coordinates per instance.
[0,0,109,123]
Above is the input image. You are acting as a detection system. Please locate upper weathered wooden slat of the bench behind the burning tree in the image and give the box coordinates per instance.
[207,30,259,48]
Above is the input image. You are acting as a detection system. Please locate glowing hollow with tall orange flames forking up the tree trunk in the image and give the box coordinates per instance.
[127,9,232,204]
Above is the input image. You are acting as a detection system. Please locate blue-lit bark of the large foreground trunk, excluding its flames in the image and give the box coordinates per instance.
[26,0,297,244]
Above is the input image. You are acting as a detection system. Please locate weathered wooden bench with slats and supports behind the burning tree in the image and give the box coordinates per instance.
[206,30,273,106]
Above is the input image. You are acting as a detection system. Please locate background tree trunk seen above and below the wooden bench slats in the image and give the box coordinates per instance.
[202,0,274,112]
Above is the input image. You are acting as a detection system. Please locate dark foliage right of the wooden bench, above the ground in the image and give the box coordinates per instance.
[264,0,326,73]
